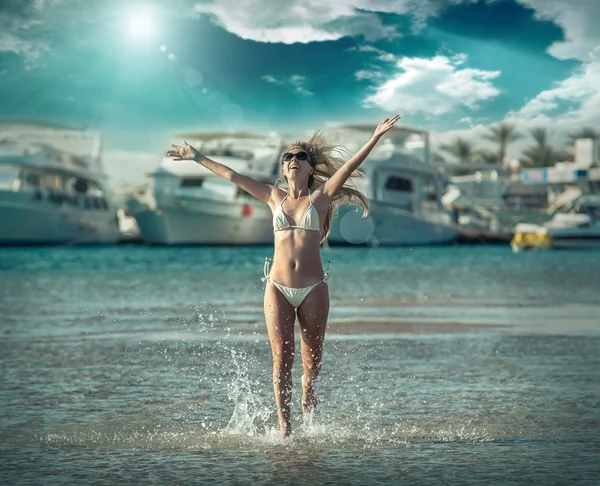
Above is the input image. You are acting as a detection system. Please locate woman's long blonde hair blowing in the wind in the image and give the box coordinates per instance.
[276,131,370,241]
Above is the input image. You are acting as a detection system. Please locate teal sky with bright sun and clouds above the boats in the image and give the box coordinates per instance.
[0,0,600,183]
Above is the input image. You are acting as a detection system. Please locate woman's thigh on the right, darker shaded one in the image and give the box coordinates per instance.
[298,282,329,350]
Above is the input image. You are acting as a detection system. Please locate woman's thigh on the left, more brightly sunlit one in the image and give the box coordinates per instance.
[264,282,296,357]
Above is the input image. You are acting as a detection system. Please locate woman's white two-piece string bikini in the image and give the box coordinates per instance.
[261,191,331,309]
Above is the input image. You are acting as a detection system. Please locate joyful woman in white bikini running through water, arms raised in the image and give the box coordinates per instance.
[167,116,400,438]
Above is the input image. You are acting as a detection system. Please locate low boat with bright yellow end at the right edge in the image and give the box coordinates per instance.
[511,194,600,252]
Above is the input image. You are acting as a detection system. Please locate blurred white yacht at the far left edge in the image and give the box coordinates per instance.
[0,124,119,245]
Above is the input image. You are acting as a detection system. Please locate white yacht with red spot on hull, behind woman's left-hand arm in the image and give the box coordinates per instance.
[127,134,283,245]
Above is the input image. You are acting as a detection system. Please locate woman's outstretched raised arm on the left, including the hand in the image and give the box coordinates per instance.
[167,141,274,204]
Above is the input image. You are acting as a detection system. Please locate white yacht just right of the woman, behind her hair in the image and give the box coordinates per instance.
[327,125,458,246]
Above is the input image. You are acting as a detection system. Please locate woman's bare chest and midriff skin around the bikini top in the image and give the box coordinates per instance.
[271,185,329,287]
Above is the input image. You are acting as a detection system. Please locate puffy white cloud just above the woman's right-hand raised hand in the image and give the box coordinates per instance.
[365,55,500,115]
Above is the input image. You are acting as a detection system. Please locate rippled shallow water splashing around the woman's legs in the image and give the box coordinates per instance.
[0,246,600,484]
